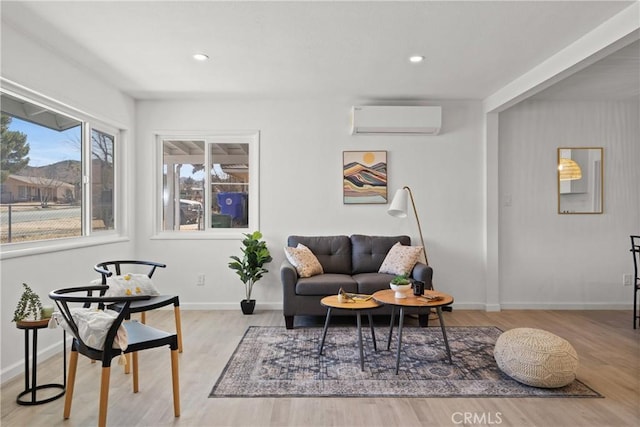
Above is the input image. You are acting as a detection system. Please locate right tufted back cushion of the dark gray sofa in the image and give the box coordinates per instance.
[351,234,411,274]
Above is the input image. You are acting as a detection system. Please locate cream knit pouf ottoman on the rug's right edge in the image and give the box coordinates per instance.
[493,328,578,388]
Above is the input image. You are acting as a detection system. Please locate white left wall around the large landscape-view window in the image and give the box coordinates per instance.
[0,22,135,381]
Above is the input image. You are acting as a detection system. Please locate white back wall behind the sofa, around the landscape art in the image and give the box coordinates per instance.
[136,99,485,310]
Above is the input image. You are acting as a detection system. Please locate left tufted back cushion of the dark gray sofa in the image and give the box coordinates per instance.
[287,236,351,274]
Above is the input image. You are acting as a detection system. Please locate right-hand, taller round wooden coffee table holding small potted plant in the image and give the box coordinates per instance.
[373,289,453,375]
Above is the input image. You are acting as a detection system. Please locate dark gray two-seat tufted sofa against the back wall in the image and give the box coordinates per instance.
[280,234,433,329]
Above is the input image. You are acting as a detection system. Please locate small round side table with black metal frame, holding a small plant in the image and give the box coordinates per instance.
[16,319,67,405]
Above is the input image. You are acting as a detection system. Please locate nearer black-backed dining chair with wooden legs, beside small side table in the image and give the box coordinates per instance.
[49,285,180,427]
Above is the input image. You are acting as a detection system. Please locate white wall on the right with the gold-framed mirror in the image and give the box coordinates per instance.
[499,99,640,309]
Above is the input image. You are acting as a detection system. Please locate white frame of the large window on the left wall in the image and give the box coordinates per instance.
[0,77,129,260]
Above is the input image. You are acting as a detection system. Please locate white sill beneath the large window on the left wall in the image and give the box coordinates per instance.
[0,234,129,260]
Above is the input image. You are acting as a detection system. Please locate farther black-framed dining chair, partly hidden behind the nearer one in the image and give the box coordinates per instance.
[93,260,182,353]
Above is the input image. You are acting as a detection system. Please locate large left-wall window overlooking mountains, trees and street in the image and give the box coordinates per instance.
[0,92,119,244]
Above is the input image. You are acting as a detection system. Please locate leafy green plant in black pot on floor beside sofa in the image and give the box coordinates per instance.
[229,231,272,314]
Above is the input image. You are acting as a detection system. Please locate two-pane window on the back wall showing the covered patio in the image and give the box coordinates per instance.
[158,133,259,235]
